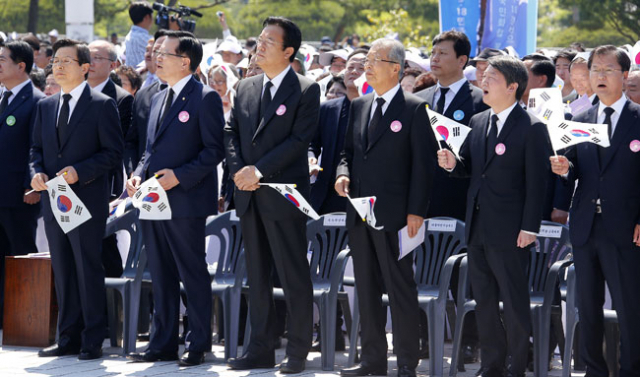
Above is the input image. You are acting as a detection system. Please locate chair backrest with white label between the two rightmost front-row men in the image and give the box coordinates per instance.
[528,221,573,294]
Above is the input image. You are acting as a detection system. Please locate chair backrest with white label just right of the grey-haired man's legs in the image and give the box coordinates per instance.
[414,217,467,288]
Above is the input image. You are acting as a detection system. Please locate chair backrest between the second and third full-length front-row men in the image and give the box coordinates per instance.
[205,210,243,283]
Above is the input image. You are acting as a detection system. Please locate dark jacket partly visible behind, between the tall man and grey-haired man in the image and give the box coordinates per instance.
[309,97,350,211]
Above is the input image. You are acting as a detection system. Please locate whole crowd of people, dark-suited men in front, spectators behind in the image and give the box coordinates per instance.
[0,2,640,377]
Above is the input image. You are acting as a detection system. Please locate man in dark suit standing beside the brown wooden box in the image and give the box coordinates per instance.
[30,39,124,360]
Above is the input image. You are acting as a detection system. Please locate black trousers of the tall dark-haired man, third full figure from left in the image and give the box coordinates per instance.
[240,199,313,358]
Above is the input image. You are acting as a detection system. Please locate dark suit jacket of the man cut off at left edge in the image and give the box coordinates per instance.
[0,82,44,207]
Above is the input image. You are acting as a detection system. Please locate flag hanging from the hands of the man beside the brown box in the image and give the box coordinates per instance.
[47,175,91,234]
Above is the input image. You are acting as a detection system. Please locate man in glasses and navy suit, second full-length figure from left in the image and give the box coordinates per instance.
[127,31,224,366]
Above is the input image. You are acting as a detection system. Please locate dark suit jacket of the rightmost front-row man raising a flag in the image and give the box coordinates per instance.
[566,100,640,248]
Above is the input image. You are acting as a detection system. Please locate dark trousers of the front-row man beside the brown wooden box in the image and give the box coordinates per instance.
[44,217,106,349]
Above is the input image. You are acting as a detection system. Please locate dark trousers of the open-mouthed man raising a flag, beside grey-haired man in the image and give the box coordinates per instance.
[467,211,531,374]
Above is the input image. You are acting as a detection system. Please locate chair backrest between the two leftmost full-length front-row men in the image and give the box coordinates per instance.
[104,204,146,279]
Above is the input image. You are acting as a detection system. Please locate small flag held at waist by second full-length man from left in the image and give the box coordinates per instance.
[131,177,171,220]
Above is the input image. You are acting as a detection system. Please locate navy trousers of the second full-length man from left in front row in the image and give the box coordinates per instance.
[140,217,212,353]
